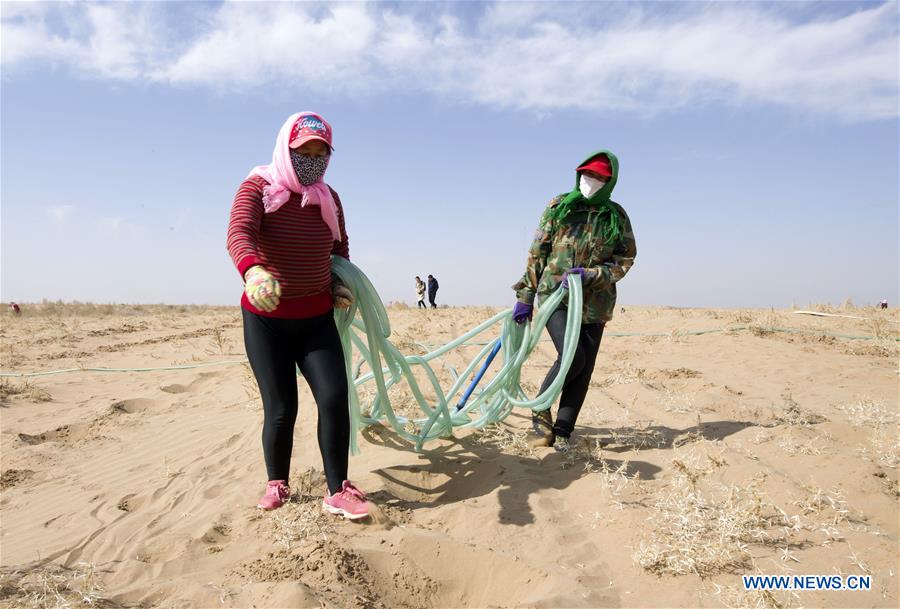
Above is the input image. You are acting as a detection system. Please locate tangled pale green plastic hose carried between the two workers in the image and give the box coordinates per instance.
[332,256,582,454]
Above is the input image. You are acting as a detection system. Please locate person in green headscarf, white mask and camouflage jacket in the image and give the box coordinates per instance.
[513,150,637,452]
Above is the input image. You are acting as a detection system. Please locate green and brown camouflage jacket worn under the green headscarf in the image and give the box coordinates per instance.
[513,195,637,324]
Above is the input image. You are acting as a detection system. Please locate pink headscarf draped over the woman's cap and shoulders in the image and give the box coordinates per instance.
[247,112,341,241]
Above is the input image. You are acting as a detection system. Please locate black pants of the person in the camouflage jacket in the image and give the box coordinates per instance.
[540,307,604,438]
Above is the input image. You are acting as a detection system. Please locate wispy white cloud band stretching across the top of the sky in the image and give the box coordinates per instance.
[2,2,900,120]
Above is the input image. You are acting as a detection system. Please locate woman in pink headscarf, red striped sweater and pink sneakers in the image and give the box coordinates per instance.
[228,112,369,519]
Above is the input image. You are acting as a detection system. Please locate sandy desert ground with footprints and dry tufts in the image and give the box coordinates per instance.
[0,304,900,608]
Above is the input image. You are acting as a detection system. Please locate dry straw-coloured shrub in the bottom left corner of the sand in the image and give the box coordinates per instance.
[0,562,111,609]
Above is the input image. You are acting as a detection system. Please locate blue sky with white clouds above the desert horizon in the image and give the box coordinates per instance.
[0,2,900,307]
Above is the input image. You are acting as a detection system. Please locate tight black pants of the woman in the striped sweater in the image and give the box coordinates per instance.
[243,310,350,493]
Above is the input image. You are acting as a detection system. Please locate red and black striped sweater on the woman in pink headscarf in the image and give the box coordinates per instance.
[227,176,350,319]
